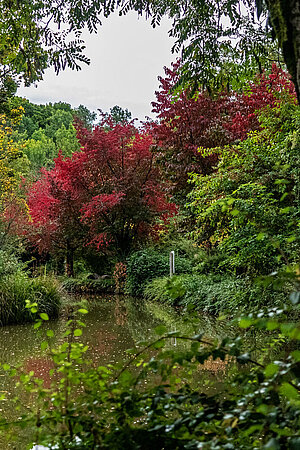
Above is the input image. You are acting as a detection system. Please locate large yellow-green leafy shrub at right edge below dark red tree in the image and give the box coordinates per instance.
[190,96,299,274]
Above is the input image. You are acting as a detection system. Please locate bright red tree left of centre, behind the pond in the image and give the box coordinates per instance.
[27,124,174,266]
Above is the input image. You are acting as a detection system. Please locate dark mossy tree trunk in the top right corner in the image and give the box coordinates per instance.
[266,0,300,103]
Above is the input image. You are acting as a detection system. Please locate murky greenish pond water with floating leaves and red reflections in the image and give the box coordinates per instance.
[0,295,262,450]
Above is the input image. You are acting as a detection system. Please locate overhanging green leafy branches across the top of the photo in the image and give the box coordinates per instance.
[0,0,300,99]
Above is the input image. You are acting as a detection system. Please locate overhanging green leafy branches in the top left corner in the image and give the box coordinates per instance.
[0,0,104,85]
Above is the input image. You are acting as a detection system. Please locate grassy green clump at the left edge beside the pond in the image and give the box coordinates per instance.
[0,273,61,326]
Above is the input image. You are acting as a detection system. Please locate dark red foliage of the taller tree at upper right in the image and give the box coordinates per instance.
[152,61,295,199]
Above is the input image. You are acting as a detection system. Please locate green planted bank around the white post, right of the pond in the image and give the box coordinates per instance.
[126,248,289,315]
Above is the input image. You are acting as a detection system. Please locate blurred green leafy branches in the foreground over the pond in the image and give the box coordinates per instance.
[1,275,300,450]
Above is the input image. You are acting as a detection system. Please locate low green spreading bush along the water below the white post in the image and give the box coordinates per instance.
[144,274,285,314]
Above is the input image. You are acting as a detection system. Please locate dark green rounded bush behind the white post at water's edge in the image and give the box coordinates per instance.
[126,249,192,296]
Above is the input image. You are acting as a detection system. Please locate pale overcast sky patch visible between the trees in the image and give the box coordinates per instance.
[18,13,176,120]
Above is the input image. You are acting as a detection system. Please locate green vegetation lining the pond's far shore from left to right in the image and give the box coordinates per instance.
[0,236,293,326]
